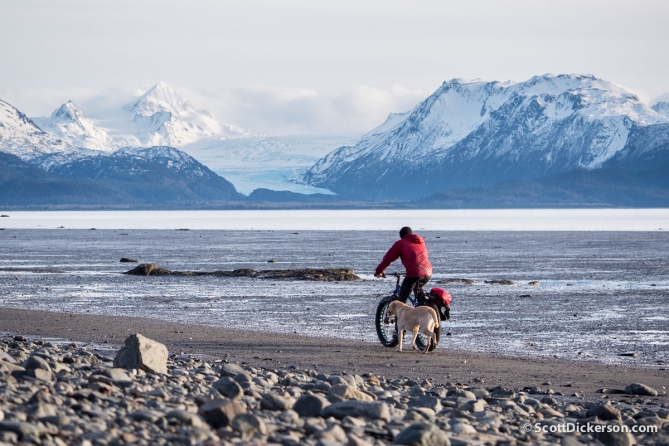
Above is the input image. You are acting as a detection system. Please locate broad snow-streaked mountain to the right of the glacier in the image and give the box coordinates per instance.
[304,74,669,199]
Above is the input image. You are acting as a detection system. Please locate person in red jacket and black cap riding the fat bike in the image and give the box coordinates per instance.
[374,226,432,303]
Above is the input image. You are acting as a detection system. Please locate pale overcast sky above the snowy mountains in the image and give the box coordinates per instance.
[0,0,669,133]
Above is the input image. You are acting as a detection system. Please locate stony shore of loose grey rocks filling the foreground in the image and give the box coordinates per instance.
[0,335,669,446]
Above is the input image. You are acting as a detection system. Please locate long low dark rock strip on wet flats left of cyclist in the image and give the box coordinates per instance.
[124,263,362,282]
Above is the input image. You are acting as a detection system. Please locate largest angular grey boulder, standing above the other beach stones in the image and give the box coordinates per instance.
[114,333,167,375]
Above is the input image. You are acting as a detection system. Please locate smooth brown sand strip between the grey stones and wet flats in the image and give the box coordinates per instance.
[0,308,669,404]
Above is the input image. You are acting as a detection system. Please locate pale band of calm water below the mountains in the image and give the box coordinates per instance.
[0,209,669,231]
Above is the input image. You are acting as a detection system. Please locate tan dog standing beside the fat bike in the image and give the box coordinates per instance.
[387,300,439,353]
